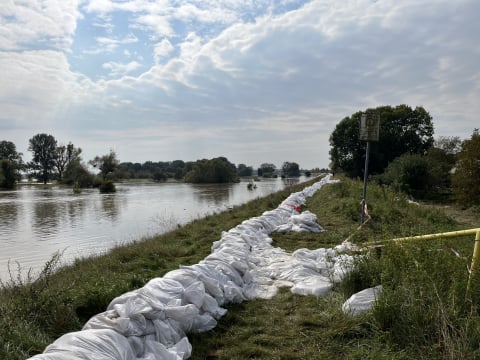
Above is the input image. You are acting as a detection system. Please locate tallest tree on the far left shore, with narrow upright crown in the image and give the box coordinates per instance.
[28,134,57,184]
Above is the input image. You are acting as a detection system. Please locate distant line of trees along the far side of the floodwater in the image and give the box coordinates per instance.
[0,133,308,192]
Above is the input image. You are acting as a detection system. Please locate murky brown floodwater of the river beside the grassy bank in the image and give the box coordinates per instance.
[0,179,308,279]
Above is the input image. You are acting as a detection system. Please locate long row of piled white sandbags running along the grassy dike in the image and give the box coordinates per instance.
[32,176,349,360]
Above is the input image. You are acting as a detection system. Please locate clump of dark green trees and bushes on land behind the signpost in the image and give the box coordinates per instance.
[330,105,480,206]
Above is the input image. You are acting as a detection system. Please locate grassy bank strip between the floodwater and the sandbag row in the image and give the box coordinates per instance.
[0,176,322,359]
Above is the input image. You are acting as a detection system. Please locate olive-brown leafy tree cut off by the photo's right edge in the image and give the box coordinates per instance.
[452,129,480,207]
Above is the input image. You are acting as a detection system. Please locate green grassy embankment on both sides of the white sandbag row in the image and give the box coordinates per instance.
[0,179,480,359]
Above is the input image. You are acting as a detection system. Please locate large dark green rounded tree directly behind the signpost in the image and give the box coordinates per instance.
[330,105,433,177]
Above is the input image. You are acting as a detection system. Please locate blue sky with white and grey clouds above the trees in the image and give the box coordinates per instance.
[0,0,480,169]
